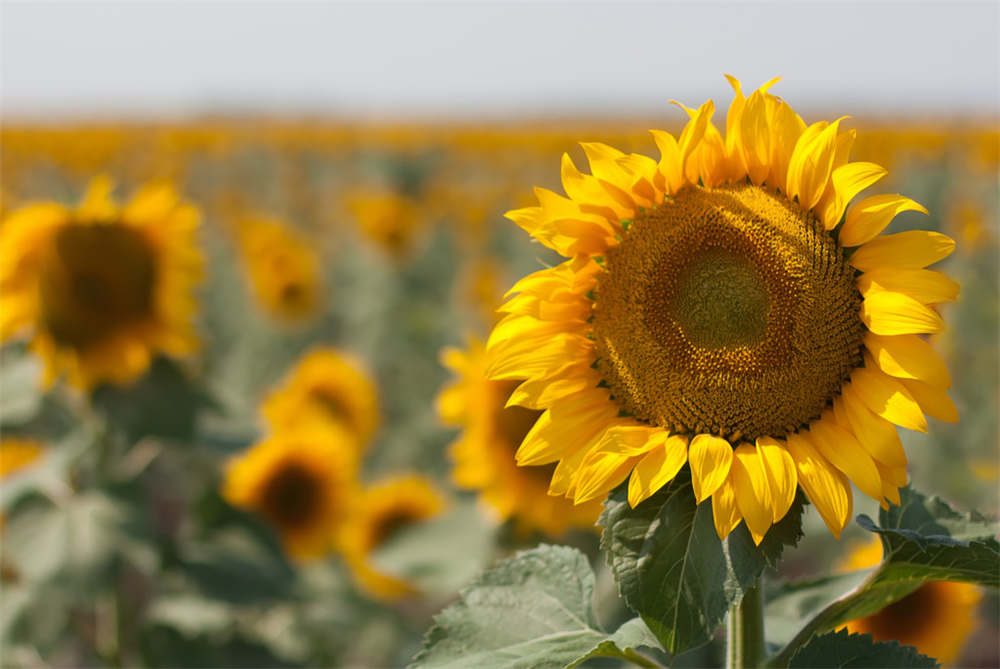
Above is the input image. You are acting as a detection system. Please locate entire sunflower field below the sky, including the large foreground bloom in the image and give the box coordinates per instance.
[0,79,1000,668]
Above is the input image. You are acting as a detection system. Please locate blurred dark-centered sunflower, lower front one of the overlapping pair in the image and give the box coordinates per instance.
[222,424,357,559]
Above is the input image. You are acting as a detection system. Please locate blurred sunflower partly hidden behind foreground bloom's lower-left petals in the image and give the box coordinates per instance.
[437,339,601,536]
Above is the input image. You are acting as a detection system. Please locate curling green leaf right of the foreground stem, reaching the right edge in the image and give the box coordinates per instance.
[767,488,1000,666]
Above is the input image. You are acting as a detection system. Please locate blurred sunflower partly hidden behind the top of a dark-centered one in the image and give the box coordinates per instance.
[262,348,379,452]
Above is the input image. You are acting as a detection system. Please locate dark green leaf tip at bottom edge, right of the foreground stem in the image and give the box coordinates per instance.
[788,630,940,669]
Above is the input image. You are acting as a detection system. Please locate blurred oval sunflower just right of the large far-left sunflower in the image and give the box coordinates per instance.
[238,218,321,323]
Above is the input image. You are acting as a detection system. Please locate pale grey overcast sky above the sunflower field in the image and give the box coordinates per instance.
[0,0,1000,118]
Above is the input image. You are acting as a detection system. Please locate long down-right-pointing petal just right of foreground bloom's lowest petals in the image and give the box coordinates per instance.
[786,434,854,539]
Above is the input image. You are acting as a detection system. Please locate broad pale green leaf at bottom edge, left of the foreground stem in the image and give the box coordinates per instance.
[411,545,656,669]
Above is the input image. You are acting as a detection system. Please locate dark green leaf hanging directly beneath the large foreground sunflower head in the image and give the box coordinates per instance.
[599,469,802,654]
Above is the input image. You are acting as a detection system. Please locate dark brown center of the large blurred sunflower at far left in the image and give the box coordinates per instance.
[39,223,156,349]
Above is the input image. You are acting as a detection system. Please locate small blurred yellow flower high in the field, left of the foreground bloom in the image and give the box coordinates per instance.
[347,191,421,258]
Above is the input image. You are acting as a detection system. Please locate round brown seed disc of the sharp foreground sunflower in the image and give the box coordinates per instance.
[594,184,864,440]
